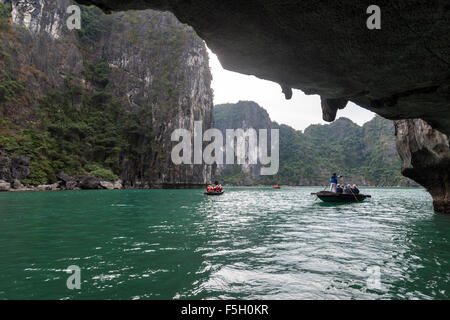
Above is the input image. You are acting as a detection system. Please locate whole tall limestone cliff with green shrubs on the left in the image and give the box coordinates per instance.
[0,0,213,187]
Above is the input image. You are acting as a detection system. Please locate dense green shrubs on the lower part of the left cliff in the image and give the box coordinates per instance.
[0,78,126,184]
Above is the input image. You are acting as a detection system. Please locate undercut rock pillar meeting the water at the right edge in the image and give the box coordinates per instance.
[395,119,450,213]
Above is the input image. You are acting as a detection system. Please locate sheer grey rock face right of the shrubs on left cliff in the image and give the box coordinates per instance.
[102,10,213,187]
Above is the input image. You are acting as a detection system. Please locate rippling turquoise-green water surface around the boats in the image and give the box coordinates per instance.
[0,187,450,299]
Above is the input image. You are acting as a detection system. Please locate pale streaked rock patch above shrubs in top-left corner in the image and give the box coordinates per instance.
[3,0,84,104]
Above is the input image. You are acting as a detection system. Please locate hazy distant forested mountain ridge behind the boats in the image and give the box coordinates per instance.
[214,101,416,186]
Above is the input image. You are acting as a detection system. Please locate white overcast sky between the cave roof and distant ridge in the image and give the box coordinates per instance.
[208,49,375,130]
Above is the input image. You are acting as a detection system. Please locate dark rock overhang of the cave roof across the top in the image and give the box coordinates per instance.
[78,0,450,135]
